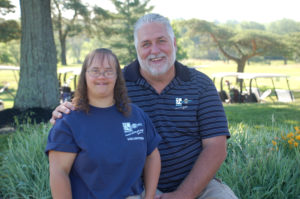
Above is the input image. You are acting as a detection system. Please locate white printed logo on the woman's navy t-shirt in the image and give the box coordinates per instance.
[122,122,144,141]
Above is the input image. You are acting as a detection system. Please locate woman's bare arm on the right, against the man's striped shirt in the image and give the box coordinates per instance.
[144,148,160,199]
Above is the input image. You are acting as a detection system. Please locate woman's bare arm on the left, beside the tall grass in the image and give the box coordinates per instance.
[49,151,77,199]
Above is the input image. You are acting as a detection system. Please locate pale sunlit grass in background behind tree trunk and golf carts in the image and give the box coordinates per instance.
[0,60,300,108]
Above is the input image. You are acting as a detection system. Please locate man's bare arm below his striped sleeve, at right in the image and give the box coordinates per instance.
[160,136,227,199]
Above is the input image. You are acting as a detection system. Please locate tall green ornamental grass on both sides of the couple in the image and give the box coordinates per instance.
[0,123,300,199]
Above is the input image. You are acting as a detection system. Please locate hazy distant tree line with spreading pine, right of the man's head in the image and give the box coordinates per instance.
[173,19,300,72]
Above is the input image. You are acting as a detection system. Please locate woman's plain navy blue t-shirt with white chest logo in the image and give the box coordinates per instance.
[46,104,161,199]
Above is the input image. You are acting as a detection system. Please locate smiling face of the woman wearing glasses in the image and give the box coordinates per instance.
[85,56,117,100]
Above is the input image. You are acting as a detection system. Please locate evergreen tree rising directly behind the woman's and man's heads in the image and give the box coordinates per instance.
[94,0,153,64]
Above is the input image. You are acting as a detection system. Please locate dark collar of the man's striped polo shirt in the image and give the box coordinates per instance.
[124,59,190,82]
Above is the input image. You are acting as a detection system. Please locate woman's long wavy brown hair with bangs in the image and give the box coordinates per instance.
[73,48,131,116]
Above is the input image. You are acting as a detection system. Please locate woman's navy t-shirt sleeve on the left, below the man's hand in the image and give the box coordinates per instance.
[45,119,79,155]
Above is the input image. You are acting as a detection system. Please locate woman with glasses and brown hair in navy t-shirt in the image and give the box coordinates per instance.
[46,48,161,199]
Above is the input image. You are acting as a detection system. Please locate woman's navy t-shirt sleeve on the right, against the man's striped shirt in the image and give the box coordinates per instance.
[144,113,161,155]
